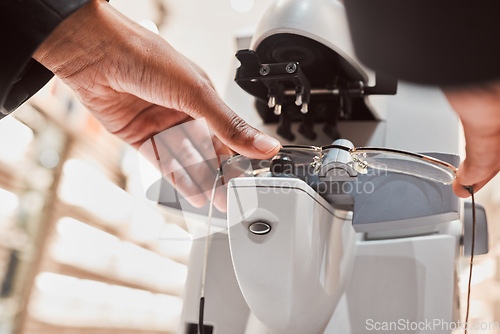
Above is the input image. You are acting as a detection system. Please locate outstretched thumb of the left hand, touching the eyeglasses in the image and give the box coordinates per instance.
[115,37,280,159]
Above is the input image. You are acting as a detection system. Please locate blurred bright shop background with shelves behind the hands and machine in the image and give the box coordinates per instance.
[0,0,500,334]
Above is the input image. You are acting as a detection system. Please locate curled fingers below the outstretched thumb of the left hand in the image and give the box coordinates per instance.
[139,118,231,211]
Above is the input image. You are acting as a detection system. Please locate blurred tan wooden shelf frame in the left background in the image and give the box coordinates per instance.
[0,83,186,334]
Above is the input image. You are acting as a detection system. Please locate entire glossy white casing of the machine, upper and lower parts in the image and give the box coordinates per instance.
[180,0,460,334]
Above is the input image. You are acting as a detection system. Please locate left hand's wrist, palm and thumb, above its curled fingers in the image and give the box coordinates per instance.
[33,0,280,206]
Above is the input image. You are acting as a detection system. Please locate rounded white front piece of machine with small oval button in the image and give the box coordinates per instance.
[228,178,355,334]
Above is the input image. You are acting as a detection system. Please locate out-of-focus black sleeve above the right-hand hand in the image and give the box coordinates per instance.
[344,0,500,86]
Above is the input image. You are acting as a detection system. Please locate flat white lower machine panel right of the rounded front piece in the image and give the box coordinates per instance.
[322,230,460,334]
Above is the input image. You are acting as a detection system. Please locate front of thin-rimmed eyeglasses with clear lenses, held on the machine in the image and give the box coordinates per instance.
[222,145,457,184]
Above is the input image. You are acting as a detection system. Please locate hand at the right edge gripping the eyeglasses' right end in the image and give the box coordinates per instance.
[445,82,500,197]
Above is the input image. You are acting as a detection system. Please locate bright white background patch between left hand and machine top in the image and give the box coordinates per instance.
[111,0,271,93]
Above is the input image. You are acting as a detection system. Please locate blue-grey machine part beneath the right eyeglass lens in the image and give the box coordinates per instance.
[310,153,460,232]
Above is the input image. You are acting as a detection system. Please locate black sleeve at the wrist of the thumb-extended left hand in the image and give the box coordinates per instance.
[0,0,90,119]
